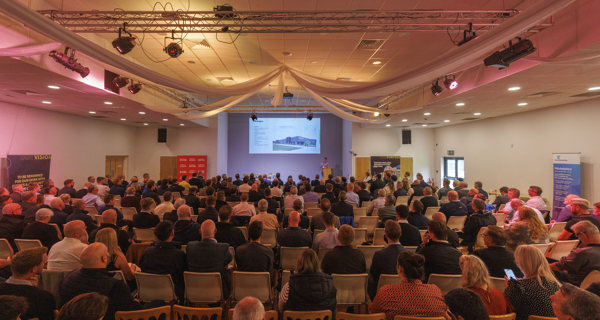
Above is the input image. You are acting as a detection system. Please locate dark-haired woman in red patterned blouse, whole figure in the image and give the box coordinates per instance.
[369,251,447,320]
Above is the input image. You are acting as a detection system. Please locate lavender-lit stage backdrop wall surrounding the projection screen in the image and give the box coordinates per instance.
[227,113,343,180]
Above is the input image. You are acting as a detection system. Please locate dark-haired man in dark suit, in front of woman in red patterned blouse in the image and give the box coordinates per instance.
[367,220,406,300]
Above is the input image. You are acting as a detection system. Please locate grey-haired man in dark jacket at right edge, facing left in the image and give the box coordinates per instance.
[550,220,600,286]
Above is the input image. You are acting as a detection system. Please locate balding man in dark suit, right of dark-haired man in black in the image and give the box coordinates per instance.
[186,220,233,299]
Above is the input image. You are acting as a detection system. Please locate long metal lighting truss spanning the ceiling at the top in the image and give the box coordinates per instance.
[38,9,551,33]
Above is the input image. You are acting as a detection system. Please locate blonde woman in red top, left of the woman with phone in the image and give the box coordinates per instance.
[459,255,512,315]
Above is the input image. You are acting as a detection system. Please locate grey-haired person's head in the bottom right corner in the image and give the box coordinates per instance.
[550,283,600,320]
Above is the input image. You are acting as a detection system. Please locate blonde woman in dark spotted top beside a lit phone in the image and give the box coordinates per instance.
[504,245,560,320]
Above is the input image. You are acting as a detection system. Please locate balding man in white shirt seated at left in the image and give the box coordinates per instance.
[48,220,87,270]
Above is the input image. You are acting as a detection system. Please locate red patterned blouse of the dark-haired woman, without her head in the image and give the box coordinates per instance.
[369,280,448,320]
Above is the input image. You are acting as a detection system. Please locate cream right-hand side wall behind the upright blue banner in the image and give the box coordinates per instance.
[434,99,600,202]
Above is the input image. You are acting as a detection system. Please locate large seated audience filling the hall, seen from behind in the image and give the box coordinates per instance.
[0,172,600,320]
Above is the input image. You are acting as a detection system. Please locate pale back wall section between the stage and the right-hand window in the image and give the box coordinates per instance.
[352,124,439,185]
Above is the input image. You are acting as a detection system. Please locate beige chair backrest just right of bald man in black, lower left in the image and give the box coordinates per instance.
[135,272,177,302]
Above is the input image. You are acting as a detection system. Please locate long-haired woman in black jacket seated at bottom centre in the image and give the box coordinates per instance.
[279,249,337,312]
